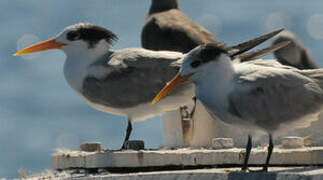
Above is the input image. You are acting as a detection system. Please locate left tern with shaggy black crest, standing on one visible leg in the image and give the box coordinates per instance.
[14,23,286,148]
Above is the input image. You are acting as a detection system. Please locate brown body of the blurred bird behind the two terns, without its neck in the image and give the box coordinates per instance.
[141,10,225,53]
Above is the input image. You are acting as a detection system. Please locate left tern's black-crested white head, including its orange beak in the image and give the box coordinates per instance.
[15,23,117,56]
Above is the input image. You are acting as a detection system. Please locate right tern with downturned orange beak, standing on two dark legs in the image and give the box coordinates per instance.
[153,40,323,171]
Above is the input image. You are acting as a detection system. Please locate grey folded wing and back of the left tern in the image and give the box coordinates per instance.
[83,48,183,108]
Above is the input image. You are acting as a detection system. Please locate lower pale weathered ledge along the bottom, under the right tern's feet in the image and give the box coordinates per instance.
[21,167,323,180]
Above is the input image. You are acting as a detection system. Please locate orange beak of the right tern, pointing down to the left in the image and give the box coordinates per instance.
[152,74,192,104]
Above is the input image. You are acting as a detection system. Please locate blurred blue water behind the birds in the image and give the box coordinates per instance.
[0,0,323,178]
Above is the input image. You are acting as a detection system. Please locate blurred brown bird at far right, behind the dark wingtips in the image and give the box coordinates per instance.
[272,30,319,69]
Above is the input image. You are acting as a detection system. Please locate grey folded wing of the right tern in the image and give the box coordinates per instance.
[228,67,322,131]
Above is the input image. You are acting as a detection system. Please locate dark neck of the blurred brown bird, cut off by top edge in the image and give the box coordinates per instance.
[149,0,178,14]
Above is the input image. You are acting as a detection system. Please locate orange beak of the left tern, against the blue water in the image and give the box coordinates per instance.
[14,39,65,56]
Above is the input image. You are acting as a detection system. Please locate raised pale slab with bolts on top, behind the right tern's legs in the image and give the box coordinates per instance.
[52,147,323,170]
